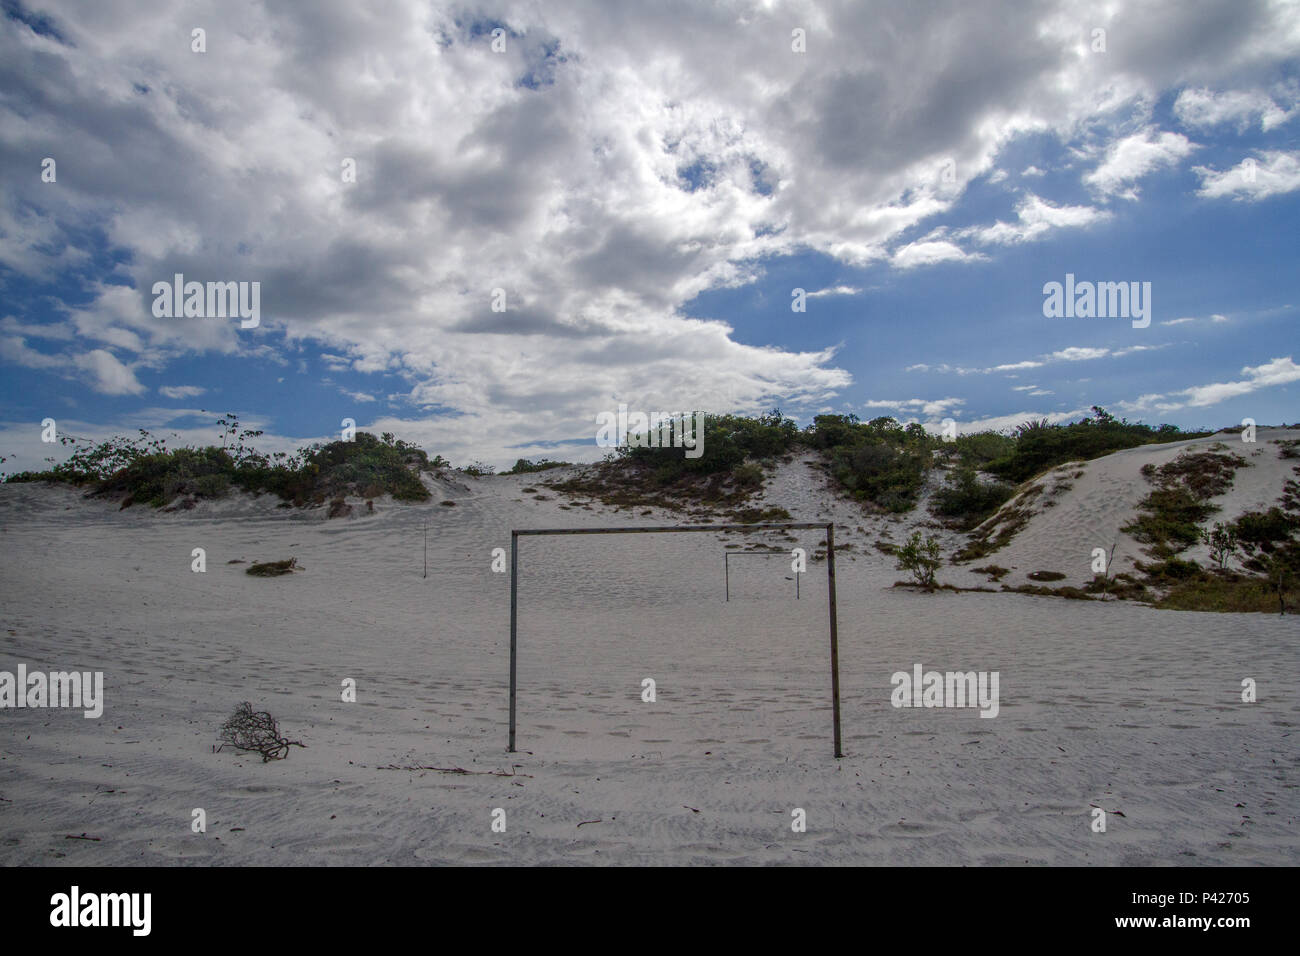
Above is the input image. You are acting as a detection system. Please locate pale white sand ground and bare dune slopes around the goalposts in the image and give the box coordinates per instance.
[0,433,1300,865]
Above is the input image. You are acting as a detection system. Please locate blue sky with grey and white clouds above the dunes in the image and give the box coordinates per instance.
[0,0,1300,471]
